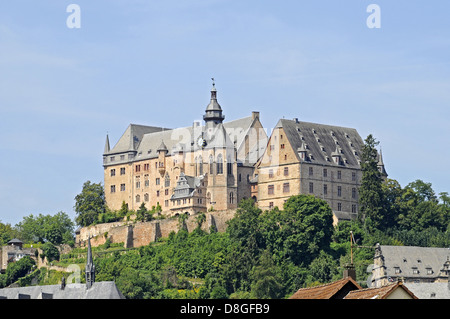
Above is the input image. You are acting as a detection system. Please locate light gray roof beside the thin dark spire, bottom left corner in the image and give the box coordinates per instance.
[0,281,125,299]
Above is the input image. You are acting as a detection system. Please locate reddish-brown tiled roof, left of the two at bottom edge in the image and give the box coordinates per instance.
[289,277,361,299]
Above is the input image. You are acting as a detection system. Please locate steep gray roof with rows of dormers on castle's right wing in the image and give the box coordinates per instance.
[276,119,364,168]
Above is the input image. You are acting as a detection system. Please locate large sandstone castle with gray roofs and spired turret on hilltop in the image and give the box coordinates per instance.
[103,82,387,223]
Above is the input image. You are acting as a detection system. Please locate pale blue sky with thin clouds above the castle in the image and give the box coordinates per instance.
[0,0,450,225]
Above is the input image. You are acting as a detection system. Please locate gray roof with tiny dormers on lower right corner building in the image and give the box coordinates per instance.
[380,245,450,279]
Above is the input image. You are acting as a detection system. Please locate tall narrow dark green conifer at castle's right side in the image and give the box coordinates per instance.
[358,134,385,229]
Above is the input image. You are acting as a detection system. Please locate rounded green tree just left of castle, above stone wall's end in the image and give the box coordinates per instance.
[74,181,106,226]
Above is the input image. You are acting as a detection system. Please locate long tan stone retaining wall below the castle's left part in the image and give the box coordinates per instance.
[76,210,235,248]
